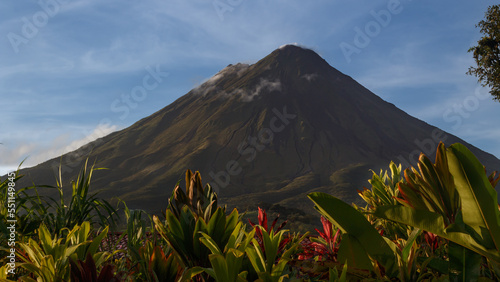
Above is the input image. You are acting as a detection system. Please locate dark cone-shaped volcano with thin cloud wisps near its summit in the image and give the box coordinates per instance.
[15,45,500,217]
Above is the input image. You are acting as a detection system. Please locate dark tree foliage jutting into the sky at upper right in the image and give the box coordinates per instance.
[467,5,500,101]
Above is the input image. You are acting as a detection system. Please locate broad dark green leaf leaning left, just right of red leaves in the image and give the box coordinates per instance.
[308,192,397,276]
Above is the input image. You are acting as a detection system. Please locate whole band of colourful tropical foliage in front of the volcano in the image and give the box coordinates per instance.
[0,144,500,281]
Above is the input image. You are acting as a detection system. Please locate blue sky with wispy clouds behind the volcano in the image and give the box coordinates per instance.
[0,0,500,175]
